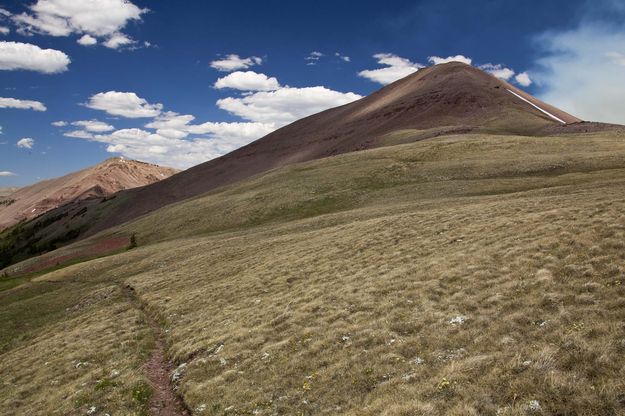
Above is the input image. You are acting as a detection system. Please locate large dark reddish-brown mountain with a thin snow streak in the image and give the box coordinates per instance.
[0,62,606,264]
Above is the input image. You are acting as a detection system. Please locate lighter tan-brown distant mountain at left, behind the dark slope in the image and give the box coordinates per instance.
[0,158,177,229]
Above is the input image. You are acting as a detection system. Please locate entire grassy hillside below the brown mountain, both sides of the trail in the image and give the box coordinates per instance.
[0,132,625,416]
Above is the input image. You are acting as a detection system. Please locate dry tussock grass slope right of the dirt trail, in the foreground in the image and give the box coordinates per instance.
[120,189,625,415]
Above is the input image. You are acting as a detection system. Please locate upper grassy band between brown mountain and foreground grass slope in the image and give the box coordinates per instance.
[91,134,625,244]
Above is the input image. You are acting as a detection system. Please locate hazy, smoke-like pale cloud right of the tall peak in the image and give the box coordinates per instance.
[532,2,625,124]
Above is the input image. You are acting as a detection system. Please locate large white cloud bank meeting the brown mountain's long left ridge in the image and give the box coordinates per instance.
[66,71,361,169]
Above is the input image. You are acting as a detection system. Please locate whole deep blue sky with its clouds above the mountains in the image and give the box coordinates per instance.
[0,0,625,187]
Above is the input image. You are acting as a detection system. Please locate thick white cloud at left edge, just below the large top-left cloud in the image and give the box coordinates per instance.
[0,42,71,74]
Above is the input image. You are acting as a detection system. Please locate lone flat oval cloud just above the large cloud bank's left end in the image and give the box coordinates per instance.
[85,91,163,118]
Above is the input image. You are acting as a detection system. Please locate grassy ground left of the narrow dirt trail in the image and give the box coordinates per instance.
[0,261,154,415]
